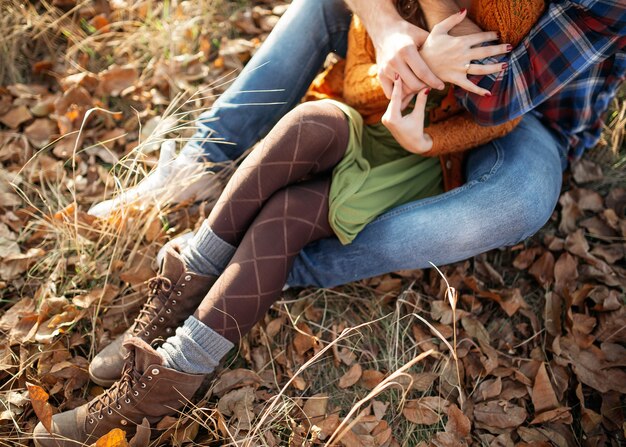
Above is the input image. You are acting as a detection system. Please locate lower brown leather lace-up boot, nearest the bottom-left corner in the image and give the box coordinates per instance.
[33,338,205,447]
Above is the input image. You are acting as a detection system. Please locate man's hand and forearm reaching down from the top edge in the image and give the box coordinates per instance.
[346,0,444,97]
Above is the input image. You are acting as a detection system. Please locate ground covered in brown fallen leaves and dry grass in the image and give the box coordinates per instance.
[0,0,626,447]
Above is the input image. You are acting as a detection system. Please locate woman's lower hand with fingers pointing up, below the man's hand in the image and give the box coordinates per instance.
[381,75,433,154]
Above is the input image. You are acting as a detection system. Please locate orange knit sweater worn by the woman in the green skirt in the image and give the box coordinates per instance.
[308,0,545,189]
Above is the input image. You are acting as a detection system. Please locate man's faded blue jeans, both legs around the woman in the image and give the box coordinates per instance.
[184,0,567,287]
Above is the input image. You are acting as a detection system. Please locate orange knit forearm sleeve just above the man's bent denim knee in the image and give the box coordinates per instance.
[422,112,522,157]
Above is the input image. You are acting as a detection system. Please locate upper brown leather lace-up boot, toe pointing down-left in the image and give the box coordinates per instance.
[89,247,216,386]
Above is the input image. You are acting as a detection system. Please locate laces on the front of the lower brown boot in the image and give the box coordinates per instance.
[88,349,142,423]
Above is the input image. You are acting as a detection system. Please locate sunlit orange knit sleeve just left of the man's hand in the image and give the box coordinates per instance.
[343,16,389,123]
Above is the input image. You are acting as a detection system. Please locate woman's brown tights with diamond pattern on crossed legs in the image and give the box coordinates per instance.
[195,103,349,343]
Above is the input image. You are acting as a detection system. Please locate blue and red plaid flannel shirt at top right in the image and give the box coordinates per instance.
[457,0,626,159]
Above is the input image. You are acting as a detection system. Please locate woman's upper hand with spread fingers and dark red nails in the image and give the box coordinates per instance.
[420,10,512,96]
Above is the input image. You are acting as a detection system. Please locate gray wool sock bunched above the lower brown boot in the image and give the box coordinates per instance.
[157,316,235,374]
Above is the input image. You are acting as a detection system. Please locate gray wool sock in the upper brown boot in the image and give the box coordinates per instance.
[181,220,236,276]
